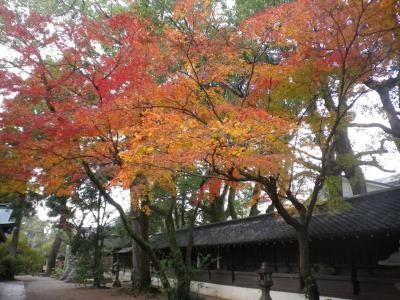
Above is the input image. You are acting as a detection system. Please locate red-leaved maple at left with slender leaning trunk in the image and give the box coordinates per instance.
[2,0,174,286]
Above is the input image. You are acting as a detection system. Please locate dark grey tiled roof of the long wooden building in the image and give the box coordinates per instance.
[151,187,400,248]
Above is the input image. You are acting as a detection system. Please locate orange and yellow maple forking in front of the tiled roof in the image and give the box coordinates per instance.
[117,1,393,299]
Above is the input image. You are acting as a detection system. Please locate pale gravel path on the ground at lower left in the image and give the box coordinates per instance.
[16,276,160,300]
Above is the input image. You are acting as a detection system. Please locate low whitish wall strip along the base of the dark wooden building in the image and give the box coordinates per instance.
[152,278,348,300]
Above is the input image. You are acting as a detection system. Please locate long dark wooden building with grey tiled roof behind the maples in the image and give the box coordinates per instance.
[117,187,400,300]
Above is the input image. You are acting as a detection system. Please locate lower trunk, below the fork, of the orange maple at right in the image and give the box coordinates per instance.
[297,227,319,300]
